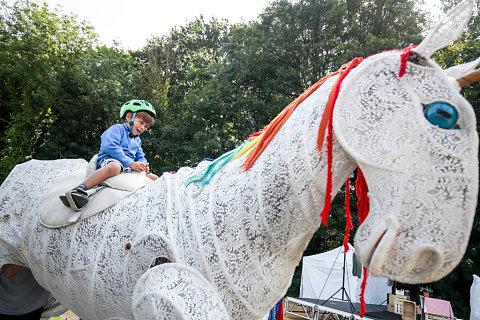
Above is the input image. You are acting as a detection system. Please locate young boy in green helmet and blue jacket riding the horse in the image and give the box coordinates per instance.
[60,100,158,211]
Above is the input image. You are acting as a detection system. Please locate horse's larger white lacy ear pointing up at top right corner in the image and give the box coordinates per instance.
[412,0,473,58]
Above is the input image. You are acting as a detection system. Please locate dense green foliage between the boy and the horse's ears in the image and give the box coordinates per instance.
[138,0,424,175]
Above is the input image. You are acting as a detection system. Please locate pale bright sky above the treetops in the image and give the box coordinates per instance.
[7,0,440,50]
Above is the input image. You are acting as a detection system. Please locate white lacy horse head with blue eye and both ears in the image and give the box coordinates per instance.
[333,0,480,283]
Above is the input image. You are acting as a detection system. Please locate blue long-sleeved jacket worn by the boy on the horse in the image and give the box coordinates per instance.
[97,123,147,168]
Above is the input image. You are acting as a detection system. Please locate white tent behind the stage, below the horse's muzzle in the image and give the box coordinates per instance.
[300,245,392,305]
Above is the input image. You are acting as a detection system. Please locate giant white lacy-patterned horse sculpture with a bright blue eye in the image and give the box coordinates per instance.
[0,0,478,320]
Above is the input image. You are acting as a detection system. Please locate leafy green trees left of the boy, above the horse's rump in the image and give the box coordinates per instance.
[0,1,142,181]
